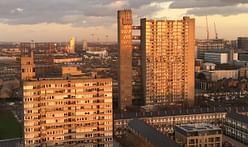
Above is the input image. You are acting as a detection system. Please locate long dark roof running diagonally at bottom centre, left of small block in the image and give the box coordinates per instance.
[128,119,181,147]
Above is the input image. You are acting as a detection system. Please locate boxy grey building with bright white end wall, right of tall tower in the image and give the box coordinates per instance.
[204,52,228,64]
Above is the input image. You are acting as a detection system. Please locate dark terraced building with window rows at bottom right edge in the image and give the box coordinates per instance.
[223,112,248,146]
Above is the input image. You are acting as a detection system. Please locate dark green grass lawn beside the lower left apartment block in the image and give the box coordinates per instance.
[0,110,22,140]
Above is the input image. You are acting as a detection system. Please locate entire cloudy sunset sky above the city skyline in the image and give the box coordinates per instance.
[0,0,248,41]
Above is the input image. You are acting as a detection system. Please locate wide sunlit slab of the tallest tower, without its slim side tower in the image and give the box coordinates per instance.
[141,17,195,106]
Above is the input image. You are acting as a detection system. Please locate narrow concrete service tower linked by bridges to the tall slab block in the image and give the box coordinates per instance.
[118,10,133,110]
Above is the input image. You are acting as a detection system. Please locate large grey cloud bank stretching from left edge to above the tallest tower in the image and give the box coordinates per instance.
[0,0,167,26]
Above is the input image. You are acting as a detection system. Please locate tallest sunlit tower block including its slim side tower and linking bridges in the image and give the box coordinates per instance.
[118,10,195,110]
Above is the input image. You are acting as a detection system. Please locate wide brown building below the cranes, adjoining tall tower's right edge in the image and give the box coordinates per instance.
[196,39,225,59]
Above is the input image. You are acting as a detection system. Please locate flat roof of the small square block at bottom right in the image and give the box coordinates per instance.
[176,123,221,133]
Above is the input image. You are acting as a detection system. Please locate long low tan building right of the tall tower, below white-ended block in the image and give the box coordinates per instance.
[203,69,239,81]
